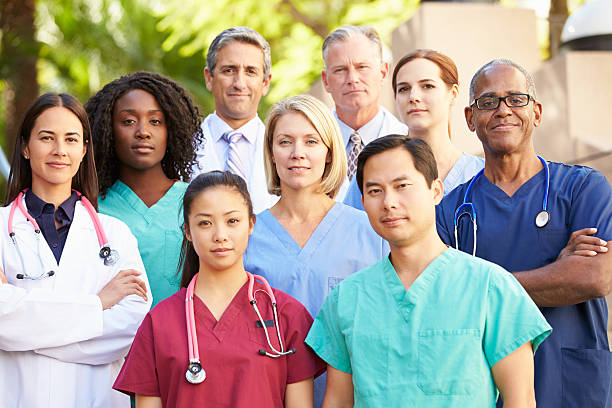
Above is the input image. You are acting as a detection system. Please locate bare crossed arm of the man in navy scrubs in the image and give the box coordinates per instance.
[514,228,612,307]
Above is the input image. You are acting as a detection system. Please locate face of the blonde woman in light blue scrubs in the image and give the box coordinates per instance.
[272,112,331,191]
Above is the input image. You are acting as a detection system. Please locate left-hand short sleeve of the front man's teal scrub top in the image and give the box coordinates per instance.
[306,286,353,374]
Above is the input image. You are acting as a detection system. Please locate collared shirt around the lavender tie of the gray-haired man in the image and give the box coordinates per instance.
[210,112,259,181]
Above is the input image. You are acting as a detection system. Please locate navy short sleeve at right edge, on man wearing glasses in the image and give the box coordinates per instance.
[569,169,612,241]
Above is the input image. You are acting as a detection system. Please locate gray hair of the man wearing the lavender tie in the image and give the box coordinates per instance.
[206,27,272,78]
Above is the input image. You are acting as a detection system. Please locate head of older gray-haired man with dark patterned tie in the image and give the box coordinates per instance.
[321,35,388,112]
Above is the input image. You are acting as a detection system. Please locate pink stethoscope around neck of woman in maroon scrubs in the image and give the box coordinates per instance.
[185,272,296,384]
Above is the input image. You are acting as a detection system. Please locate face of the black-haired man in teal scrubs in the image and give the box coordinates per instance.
[362,147,443,247]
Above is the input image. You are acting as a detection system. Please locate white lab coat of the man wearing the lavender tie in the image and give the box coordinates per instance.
[192,113,278,214]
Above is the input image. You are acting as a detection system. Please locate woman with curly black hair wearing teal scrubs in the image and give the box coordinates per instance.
[86,72,202,303]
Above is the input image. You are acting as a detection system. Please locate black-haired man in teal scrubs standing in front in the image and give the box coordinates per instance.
[306,136,551,408]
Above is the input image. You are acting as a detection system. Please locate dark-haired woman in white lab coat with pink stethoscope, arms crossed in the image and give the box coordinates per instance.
[0,94,151,408]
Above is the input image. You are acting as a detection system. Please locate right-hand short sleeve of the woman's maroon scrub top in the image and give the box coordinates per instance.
[285,300,325,384]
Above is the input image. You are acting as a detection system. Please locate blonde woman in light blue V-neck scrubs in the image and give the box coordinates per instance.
[245,95,388,406]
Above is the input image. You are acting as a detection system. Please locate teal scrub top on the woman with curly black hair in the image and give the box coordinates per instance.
[98,180,188,306]
